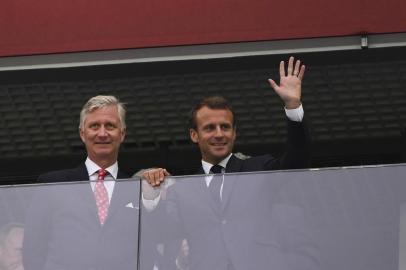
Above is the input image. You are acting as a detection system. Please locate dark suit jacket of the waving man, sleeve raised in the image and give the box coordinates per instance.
[160,121,318,270]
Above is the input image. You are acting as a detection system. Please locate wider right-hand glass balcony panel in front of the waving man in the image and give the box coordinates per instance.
[141,165,406,270]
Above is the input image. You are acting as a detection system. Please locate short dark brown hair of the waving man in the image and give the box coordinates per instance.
[189,96,236,130]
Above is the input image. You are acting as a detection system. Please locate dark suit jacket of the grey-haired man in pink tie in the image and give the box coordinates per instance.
[23,164,144,270]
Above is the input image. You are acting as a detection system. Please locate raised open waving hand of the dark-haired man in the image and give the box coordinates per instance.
[268,56,305,109]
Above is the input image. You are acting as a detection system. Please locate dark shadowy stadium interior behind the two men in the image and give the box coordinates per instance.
[0,47,406,184]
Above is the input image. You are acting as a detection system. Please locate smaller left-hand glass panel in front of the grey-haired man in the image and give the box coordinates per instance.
[0,181,143,270]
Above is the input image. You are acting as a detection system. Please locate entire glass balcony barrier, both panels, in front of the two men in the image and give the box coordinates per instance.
[0,165,406,270]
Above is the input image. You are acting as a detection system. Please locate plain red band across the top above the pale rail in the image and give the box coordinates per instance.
[0,0,406,56]
